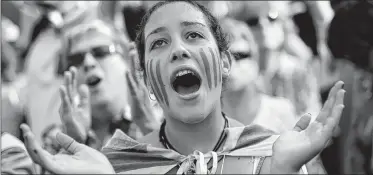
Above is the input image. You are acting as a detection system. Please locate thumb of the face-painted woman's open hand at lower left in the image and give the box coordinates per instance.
[56,132,85,154]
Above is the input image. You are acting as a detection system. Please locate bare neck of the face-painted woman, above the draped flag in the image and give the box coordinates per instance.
[165,101,225,155]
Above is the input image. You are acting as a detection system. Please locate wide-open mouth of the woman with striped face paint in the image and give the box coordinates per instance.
[171,68,201,95]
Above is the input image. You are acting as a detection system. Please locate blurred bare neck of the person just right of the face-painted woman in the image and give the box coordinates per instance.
[223,84,261,125]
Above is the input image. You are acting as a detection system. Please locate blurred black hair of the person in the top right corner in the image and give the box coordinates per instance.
[328,1,373,69]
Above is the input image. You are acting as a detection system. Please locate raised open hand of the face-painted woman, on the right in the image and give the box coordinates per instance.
[273,81,345,172]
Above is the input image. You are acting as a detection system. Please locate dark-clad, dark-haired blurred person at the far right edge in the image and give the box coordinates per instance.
[323,1,373,174]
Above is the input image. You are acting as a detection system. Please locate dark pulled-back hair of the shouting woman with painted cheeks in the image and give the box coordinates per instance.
[132,0,228,75]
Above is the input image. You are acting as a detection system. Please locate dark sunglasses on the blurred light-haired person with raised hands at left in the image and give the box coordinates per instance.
[67,45,120,67]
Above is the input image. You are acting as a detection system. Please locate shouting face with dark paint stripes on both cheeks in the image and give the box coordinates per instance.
[144,2,227,123]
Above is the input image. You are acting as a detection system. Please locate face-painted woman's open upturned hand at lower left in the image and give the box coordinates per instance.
[21,124,115,174]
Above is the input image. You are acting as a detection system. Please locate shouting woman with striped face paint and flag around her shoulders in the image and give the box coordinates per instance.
[22,1,344,174]
